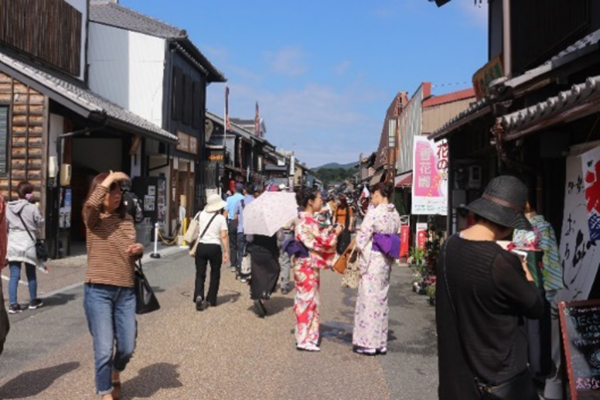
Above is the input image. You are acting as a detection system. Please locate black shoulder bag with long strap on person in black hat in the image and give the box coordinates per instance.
[441,235,539,400]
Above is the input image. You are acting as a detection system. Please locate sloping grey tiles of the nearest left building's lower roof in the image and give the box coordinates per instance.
[0,52,178,143]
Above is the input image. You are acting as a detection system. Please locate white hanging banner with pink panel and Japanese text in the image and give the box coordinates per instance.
[412,136,448,215]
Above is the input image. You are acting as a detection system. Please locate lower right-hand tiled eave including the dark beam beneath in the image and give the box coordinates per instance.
[498,76,600,140]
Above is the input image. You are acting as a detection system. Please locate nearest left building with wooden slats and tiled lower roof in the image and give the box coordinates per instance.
[0,0,177,257]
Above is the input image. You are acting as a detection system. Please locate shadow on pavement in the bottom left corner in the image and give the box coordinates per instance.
[0,362,79,399]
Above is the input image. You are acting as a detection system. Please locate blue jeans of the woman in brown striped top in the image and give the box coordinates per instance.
[83,283,137,395]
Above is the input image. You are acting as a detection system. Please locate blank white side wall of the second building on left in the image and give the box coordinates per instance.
[88,22,166,126]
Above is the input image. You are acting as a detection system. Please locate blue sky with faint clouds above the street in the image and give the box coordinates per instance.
[121,0,487,167]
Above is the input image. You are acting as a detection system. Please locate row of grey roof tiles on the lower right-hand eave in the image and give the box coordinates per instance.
[498,76,600,139]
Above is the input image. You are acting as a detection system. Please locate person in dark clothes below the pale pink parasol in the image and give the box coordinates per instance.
[248,235,280,318]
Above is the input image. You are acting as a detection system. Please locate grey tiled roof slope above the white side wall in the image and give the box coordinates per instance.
[90,1,186,38]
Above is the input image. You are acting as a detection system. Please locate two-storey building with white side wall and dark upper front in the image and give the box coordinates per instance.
[89,0,225,235]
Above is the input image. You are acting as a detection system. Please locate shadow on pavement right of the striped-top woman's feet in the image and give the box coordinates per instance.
[122,363,183,399]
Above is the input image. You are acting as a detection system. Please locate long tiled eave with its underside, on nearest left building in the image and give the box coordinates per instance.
[0,52,178,143]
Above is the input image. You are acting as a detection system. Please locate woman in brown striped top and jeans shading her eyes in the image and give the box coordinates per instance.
[83,171,144,400]
